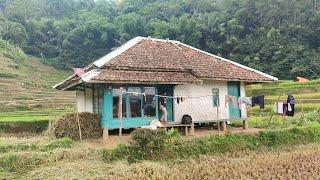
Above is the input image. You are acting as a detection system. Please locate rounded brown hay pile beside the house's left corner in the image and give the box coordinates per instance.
[53,112,102,140]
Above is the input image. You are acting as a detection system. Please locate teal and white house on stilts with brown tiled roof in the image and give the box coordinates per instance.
[54,37,277,138]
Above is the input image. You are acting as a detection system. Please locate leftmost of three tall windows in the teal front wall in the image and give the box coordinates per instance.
[112,88,127,118]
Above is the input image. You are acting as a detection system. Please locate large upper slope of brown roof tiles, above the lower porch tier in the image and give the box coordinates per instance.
[104,39,273,82]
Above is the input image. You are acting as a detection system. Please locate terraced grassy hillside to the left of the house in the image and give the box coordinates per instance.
[0,53,75,121]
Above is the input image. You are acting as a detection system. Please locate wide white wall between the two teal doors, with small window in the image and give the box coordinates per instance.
[174,81,229,122]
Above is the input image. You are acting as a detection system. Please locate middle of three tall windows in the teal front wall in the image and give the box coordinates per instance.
[128,87,142,117]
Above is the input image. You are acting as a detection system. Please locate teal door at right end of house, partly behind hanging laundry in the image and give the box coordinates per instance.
[228,82,241,119]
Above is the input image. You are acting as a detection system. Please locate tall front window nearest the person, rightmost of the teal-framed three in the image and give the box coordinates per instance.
[143,87,156,117]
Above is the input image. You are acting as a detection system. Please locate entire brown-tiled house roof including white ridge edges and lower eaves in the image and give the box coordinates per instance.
[54,37,277,89]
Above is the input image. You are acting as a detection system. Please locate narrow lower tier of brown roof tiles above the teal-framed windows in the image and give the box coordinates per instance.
[91,69,202,84]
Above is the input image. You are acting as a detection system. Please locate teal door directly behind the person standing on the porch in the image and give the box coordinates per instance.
[157,85,173,121]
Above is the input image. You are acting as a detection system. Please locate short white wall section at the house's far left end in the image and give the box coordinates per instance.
[76,88,93,113]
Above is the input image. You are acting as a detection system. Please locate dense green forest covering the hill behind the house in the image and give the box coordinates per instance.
[0,0,320,79]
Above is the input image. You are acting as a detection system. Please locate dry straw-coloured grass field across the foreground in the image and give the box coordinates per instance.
[0,137,320,179]
